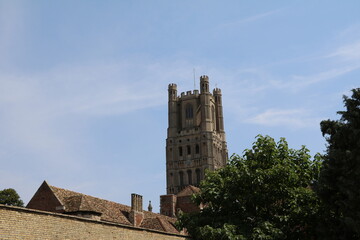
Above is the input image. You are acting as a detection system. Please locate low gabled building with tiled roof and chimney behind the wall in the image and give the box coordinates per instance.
[26,181,182,235]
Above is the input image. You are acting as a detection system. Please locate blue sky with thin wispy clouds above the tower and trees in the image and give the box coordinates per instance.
[0,0,360,211]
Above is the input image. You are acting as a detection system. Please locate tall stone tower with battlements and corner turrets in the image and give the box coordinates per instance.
[166,76,228,194]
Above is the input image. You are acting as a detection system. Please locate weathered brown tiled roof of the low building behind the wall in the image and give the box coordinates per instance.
[49,185,179,234]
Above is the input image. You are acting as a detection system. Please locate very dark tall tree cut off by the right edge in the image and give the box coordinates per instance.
[317,88,360,239]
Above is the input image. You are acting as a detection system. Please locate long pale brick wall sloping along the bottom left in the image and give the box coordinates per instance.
[0,204,189,240]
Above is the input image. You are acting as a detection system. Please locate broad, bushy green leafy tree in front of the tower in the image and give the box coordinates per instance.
[177,135,321,240]
